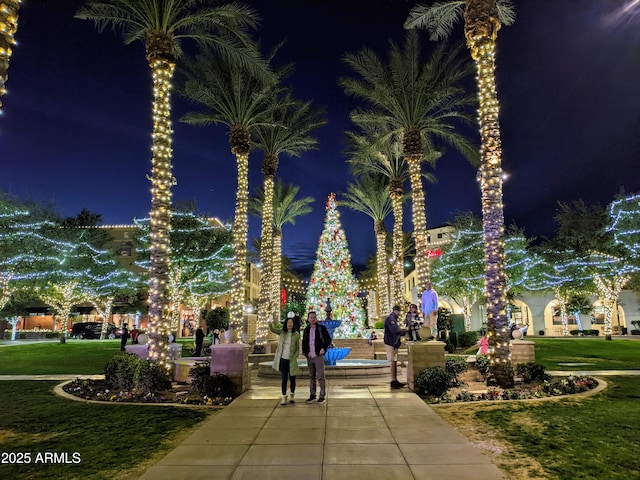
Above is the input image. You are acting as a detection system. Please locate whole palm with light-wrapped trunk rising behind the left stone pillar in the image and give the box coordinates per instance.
[182,48,280,338]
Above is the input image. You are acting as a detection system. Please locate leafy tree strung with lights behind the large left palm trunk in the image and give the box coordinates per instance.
[134,205,233,331]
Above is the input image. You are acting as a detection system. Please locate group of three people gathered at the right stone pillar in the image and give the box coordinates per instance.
[384,282,438,389]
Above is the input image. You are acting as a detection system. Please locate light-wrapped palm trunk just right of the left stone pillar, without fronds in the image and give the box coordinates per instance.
[256,175,277,345]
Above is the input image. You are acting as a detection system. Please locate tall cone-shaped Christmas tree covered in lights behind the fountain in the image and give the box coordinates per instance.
[307,193,365,338]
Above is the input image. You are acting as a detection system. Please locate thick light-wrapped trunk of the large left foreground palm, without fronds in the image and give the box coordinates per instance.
[149,56,175,362]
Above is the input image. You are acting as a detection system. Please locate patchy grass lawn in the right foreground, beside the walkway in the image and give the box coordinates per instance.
[436,377,640,480]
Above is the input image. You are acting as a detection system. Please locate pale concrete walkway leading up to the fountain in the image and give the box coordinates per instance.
[141,382,506,480]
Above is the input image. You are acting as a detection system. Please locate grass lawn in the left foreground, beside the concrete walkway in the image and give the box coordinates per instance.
[0,380,216,480]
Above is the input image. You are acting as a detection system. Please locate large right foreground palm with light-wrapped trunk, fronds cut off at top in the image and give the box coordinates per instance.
[405,0,515,388]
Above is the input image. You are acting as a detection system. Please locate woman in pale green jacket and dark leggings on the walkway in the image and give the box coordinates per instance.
[269,318,300,405]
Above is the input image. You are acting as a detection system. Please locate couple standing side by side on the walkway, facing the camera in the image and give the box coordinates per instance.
[270,311,331,405]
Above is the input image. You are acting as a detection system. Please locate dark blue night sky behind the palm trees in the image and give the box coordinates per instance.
[0,0,640,266]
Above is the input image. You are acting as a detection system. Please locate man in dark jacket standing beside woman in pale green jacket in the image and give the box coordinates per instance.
[302,312,331,404]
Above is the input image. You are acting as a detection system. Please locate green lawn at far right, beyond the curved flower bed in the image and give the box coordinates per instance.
[527,337,640,370]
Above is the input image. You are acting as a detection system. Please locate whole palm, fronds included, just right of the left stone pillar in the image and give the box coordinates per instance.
[255,94,326,346]
